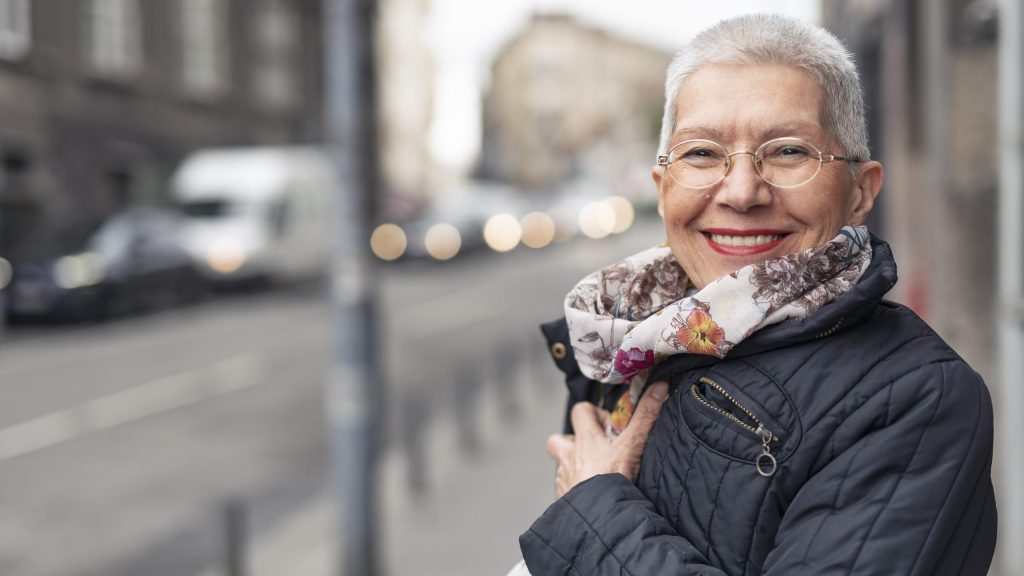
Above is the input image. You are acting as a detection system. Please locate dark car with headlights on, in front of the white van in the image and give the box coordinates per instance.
[5,208,205,320]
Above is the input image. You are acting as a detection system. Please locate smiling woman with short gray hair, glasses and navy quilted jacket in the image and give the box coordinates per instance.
[520,15,996,576]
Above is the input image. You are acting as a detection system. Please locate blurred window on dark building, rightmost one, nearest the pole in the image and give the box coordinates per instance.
[253,0,301,109]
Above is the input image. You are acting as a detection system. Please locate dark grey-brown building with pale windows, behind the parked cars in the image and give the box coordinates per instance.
[0,0,323,240]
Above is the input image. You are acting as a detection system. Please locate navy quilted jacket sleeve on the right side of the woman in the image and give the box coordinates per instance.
[764,360,996,576]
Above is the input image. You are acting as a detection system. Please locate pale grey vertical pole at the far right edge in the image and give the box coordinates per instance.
[996,0,1024,574]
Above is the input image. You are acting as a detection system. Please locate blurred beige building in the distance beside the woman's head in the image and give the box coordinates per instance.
[479,14,671,196]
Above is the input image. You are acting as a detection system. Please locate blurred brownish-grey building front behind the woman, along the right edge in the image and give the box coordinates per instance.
[822,0,1024,575]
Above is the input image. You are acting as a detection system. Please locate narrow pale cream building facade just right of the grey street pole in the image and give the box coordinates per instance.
[377,0,436,208]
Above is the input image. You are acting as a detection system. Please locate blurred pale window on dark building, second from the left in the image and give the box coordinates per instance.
[86,0,142,78]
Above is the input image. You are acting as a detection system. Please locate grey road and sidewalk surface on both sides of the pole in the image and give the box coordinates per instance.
[0,219,662,576]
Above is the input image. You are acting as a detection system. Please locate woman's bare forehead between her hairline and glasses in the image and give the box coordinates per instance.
[673,65,825,141]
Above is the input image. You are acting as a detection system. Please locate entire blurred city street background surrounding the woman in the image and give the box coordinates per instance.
[0,0,1024,576]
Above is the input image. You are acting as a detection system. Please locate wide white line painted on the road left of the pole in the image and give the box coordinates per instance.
[0,354,262,461]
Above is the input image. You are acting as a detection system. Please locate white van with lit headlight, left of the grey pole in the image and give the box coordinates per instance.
[171,147,339,283]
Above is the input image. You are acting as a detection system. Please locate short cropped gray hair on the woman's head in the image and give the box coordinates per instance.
[658,14,870,166]
